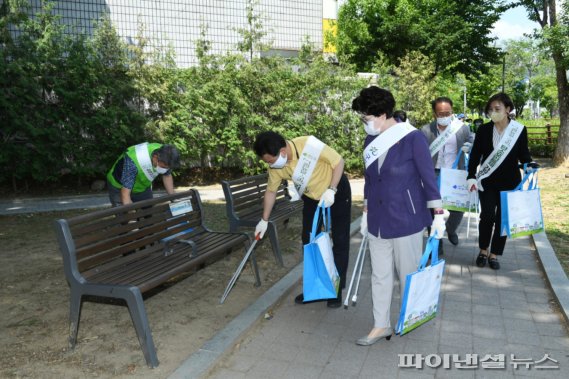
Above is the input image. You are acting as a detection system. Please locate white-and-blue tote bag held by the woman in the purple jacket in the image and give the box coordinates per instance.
[395,236,445,335]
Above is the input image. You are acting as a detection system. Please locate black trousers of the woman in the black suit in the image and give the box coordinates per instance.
[478,189,508,255]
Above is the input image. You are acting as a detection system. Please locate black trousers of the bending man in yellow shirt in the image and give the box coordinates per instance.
[302,175,352,289]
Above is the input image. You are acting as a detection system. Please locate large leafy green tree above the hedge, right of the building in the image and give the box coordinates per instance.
[336,0,505,76]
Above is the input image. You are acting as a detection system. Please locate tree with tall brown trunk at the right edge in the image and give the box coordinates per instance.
[516,0,569,164]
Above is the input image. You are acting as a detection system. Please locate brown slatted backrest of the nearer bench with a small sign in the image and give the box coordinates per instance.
[56,190,205,281]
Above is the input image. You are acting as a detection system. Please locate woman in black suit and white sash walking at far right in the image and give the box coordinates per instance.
[468,93,532,270]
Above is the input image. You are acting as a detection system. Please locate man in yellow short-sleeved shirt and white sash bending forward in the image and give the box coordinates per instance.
[253,131,352,308]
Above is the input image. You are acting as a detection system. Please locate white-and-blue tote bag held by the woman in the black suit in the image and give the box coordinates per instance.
[500,165,544,238]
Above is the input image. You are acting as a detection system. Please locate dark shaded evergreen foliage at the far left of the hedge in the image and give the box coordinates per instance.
[0,1,144,189]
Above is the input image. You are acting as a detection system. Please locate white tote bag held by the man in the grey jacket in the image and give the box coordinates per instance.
[439,149,475,212]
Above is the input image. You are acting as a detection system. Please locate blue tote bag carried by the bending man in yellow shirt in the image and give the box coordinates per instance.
[302,206,340,302]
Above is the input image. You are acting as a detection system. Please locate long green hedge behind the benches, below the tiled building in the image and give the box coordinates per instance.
[0,1,367,189]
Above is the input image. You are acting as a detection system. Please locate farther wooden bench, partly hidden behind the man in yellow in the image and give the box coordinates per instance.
[221,174,303,266]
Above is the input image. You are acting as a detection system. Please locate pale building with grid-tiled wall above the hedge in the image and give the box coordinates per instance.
[21,0,338,67]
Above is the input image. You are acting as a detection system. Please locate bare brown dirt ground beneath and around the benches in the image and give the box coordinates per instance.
[0,202,361,379]
